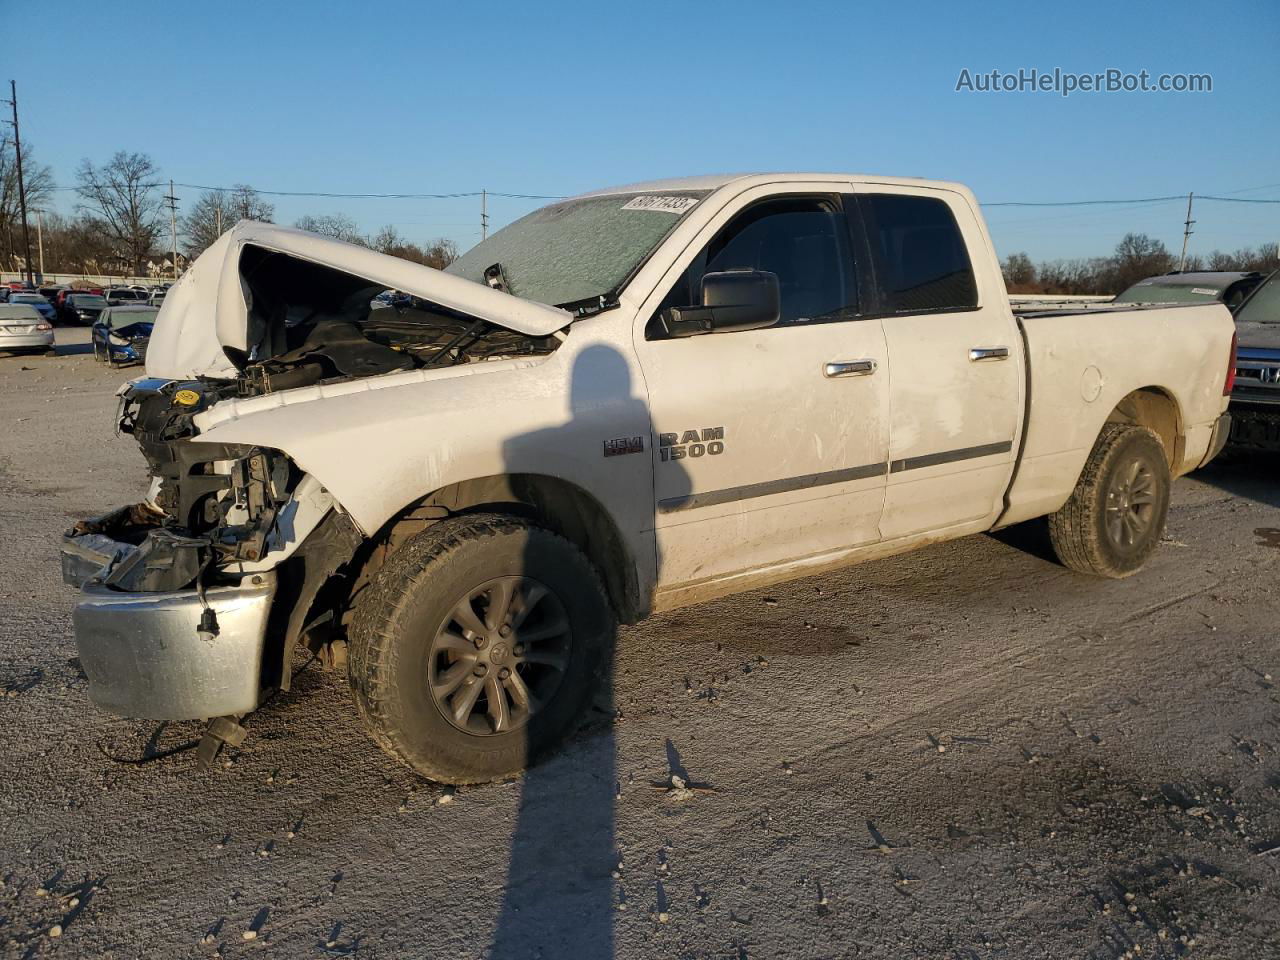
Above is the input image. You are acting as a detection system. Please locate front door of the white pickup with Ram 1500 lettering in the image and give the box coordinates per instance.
[636,184,890,588]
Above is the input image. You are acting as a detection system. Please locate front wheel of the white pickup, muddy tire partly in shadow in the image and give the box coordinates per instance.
[347,513,616,783]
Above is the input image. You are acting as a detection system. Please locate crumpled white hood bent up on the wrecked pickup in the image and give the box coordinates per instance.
[146,220,572,379]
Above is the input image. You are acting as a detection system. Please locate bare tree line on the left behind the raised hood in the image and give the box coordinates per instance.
[0,140,458,276]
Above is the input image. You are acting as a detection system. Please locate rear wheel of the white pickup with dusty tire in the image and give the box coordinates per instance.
[1048,424,1172,579]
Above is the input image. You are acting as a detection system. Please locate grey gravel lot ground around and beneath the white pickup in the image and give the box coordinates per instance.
[0,330,1280,960]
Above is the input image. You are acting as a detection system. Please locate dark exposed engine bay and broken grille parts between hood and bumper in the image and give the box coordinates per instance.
[64,244,562,593]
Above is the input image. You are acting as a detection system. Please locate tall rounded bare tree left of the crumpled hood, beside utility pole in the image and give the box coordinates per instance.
[76,150,161,275]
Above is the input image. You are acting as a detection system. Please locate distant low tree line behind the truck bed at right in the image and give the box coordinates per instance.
[1000,233,1280,294]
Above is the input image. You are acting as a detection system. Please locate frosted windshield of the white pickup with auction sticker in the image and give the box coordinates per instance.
[445,191,707,313]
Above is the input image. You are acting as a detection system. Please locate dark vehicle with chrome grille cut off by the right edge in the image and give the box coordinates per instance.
[1230,270,1280,451]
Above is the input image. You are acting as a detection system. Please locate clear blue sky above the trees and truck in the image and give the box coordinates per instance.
[10,0,1280,260]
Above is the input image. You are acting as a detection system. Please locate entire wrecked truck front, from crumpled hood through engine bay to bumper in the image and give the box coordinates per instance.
[63,221,572,719]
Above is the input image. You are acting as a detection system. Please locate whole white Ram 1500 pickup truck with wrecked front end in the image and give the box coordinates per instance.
[63,174,1234,782]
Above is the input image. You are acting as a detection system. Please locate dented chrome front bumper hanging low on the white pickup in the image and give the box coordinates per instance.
[73,573,275,721]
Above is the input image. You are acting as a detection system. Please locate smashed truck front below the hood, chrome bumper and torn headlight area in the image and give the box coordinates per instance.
[61,379,360,719]
